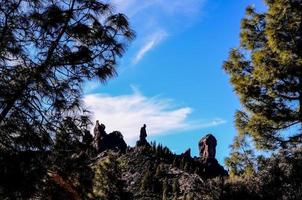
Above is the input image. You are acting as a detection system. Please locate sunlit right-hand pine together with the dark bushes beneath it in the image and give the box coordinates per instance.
[222,0,302,199]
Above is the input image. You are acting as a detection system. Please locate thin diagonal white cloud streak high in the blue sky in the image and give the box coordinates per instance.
[133,31,168,64]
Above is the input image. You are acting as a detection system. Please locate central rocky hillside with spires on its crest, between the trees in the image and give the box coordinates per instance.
[38,123,227,200]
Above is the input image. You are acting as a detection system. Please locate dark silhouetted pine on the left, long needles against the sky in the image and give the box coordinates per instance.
[0,0,134,151]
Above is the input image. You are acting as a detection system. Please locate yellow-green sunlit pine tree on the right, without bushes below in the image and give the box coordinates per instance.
[224,0,302,149]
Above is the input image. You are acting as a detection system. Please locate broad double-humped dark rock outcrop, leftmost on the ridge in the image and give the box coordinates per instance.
[93,121,127,153]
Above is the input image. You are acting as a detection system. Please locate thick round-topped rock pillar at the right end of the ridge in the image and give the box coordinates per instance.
[198,134,217,159]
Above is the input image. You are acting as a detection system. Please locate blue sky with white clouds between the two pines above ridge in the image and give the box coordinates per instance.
[84,0,265,164]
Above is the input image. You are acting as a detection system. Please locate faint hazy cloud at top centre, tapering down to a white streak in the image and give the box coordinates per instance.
[108,0,206,65]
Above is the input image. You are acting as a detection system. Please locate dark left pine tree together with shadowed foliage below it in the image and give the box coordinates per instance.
[0,0,134,199]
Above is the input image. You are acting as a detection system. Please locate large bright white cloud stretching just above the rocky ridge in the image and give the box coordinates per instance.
[84,89,225,144]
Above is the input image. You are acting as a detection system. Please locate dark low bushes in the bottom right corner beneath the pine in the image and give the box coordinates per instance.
[203,148,302,200]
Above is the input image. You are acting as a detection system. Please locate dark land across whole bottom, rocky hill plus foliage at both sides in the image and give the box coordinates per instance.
[0,123,302,200]
